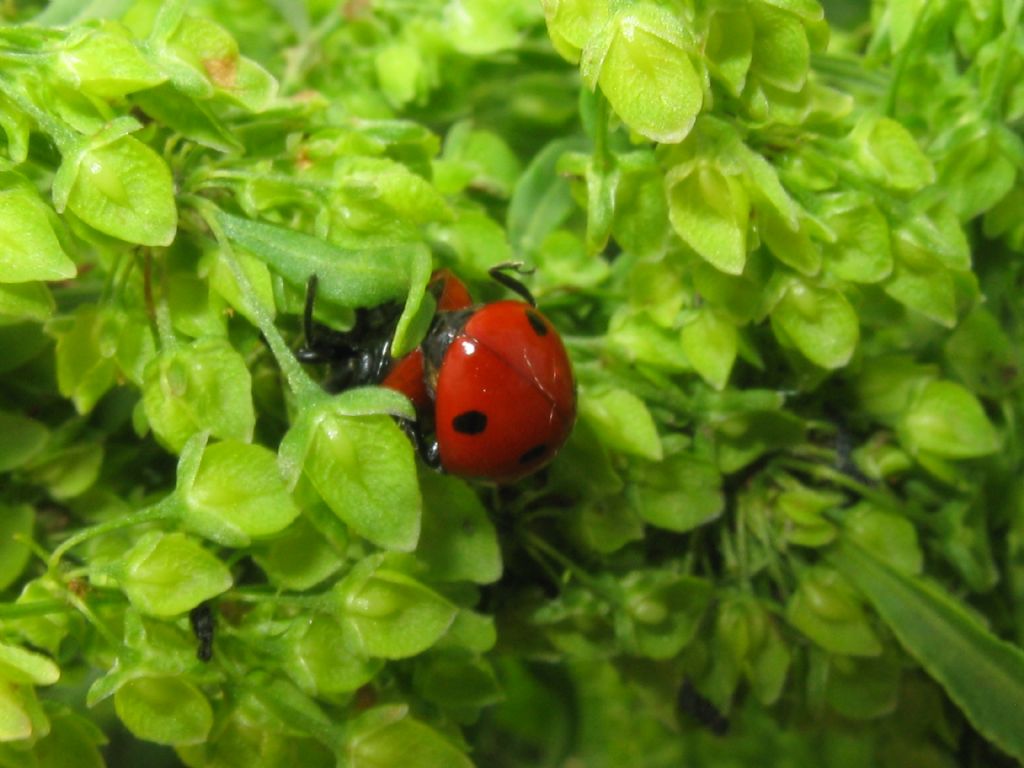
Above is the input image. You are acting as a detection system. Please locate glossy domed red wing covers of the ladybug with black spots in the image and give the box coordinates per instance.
[434,301,575,482]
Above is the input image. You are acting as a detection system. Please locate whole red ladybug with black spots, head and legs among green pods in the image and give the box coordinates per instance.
[296,264,577,482]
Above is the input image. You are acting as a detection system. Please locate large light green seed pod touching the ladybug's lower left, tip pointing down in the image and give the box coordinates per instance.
[281,401,422,552]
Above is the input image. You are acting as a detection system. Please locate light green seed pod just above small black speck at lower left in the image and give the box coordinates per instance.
[114,530,232,616]
